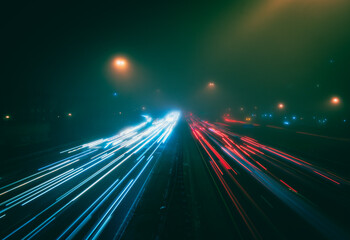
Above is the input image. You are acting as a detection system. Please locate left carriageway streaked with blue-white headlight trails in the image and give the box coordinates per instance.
[0,113,178,239]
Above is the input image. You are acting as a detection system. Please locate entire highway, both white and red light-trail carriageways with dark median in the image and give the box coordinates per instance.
[0,113,350,240]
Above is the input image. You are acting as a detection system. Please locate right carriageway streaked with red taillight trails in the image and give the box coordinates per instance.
[187,116,350,239]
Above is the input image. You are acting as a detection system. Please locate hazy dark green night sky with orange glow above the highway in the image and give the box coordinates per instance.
[0,0,350,115]
